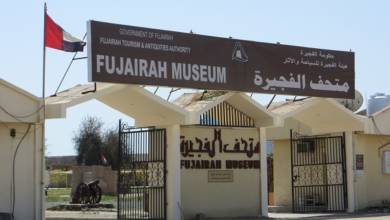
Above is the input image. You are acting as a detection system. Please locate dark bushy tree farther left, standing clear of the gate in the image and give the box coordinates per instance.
[73,116,103,166]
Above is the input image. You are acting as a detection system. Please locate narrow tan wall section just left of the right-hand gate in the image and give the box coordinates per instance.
[273,140,292,211]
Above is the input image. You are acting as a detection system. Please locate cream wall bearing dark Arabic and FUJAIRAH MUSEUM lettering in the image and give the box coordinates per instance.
[181,127,261,219]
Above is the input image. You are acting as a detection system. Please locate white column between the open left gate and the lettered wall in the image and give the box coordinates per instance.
[166,125,181,220]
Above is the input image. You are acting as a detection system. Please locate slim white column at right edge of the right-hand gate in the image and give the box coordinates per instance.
[345,131,355,212]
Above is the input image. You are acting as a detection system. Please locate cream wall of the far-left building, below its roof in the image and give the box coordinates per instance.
[0,123,41,220]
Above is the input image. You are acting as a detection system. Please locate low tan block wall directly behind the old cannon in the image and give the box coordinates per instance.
[72,166,118,194]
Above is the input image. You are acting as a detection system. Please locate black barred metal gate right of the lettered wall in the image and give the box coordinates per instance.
[290,132,348,212]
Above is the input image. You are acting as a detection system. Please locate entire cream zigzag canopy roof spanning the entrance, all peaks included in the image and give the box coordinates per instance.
[43,83,390,138]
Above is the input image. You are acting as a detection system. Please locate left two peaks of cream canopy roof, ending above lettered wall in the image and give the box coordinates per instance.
[46,83,274,126]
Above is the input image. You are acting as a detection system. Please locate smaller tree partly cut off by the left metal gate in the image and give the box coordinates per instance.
[103,128,119,170]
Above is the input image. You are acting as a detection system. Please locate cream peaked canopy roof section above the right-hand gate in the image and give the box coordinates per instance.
[269,98,366,138]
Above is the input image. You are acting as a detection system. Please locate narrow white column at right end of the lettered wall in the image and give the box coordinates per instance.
[260,128,268,217]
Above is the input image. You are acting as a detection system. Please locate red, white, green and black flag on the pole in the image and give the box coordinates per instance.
[45,13,85,52]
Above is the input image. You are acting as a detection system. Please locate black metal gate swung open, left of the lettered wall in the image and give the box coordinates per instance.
[118,122,166,220]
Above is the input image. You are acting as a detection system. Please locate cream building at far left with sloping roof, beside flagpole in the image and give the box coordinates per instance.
[0,79,44,220]
